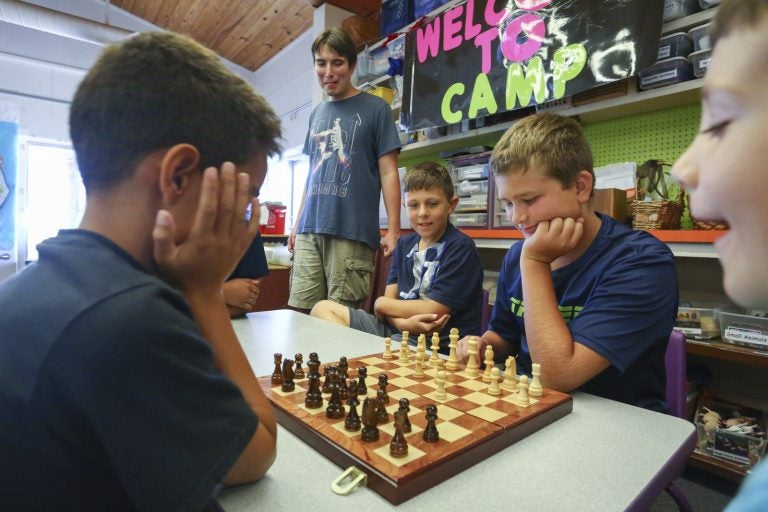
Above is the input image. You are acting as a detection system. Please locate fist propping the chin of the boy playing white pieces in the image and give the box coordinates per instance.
[521,217,584,264]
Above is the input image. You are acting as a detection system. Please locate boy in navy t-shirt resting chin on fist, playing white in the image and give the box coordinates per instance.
[458,113,677,411]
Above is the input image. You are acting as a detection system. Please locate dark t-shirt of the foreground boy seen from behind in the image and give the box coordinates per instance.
[0,230,258,511]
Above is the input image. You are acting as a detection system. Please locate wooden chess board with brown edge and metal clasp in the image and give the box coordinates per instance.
[259,352,573,504]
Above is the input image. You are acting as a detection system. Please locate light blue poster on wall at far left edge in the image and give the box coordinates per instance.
[0,100,19,259]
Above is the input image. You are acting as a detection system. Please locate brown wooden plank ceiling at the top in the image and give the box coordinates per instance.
[111,0,381,71]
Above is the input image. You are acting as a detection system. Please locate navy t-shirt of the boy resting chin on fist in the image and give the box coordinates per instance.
[489,213,678,412]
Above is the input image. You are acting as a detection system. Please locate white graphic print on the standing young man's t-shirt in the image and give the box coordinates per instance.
[307,114,362,197]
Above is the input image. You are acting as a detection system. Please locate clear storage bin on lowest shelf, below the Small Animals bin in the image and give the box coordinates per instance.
[695,393,766,467]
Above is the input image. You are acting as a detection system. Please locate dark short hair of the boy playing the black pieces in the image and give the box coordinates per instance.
[69,32,280,191]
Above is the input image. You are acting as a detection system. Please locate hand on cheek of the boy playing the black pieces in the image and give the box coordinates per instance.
[152,162,259,294]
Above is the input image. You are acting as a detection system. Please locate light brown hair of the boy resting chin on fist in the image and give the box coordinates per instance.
[490,113,594,188]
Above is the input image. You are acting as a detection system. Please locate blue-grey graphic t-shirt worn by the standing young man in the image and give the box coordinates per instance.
[297,93,400,249]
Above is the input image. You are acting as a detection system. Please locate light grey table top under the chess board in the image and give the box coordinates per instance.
[219,310,695,512]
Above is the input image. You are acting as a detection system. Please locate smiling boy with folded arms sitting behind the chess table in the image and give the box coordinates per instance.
[311,162,483,353]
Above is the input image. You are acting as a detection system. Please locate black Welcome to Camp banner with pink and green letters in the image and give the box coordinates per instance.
[402,0,664,131]
